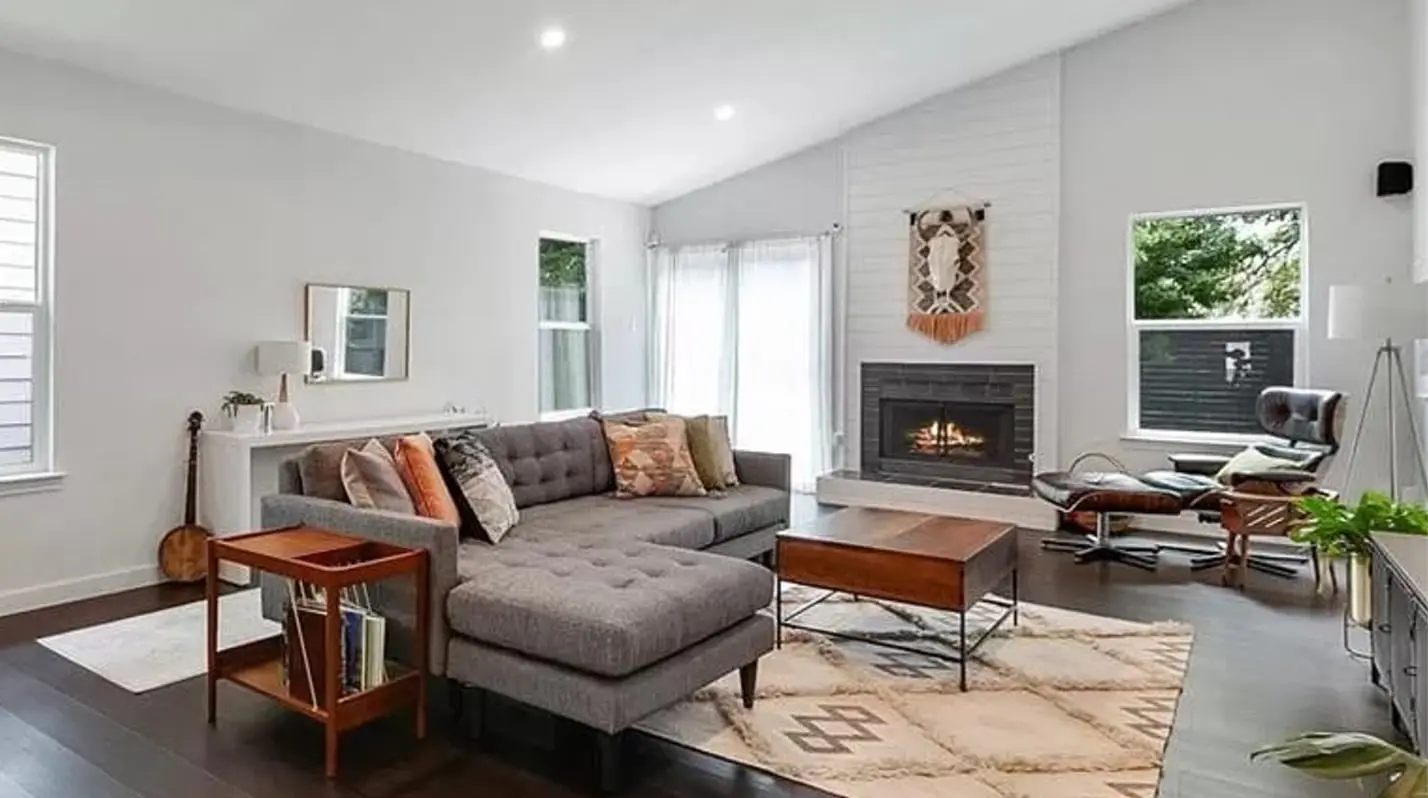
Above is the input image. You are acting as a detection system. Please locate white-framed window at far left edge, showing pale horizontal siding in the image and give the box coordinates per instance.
[0,138,53,477]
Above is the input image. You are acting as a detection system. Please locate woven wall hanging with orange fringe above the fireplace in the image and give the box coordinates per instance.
[907,206,987,344]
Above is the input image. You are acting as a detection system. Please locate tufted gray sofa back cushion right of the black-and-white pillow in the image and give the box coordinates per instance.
[478,418,614,508]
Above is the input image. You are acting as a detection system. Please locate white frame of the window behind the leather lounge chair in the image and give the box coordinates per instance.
[1122,203,1309,445]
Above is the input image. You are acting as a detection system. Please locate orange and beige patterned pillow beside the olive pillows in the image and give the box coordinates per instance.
[604,417,708,498]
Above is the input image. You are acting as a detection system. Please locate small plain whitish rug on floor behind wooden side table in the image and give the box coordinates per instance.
[40,590,280,692]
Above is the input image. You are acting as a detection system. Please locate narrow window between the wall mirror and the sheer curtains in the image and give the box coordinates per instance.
[540,236,595,418]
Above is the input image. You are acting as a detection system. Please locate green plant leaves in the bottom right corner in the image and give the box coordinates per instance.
[1250,731,1428,798]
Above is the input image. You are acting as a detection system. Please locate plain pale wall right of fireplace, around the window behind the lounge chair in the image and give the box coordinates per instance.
[1060,0,1418,493]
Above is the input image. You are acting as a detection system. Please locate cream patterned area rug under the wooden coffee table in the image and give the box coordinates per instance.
[640,587,1191,798]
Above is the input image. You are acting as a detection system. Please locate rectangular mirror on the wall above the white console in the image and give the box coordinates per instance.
[307,283,411,383]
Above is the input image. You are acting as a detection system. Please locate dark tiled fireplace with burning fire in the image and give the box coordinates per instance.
[860,363,1035,495]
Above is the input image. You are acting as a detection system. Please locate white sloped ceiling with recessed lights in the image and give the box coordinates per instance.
[0,0,1182,203]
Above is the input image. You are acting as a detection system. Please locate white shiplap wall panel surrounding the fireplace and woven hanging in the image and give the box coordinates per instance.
[844,57,1061,468]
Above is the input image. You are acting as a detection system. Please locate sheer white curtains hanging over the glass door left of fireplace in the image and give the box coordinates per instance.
[651,236,833,491]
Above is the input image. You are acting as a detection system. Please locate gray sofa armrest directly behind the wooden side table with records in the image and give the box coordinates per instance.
[260,494,460,675]
